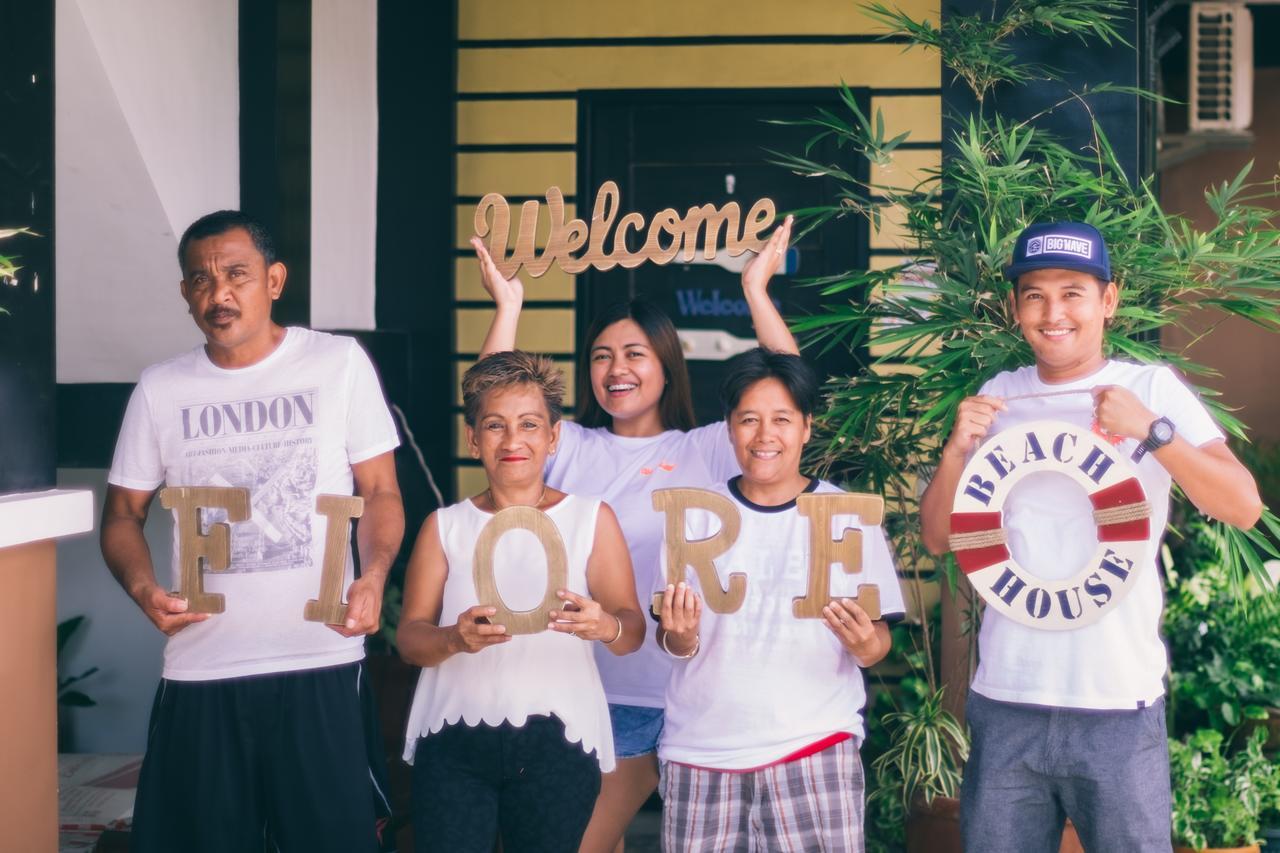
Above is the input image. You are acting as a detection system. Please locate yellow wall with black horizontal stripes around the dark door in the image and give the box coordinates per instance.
[451,0,942,497]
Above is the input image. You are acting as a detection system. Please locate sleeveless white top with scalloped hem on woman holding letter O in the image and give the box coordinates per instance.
[404,494,614,772]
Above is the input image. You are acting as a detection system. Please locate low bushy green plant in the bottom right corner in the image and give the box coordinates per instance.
[1169,729,1280,853]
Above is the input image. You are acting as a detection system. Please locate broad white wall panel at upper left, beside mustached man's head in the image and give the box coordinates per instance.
[54,0,239,382]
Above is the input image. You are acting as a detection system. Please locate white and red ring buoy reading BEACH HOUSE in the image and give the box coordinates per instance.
[950,420,1152,630]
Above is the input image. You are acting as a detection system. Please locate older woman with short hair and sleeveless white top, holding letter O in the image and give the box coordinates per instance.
[396,351,646,853]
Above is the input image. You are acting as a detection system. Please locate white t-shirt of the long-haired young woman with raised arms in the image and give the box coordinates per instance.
[547,421,740,708]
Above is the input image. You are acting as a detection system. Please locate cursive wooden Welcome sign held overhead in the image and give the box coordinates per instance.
[475,181,777,278]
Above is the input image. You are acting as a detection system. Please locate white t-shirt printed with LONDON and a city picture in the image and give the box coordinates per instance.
[106,327,399,681]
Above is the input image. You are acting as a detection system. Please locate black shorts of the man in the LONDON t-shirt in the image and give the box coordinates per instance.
[129,663,390,853]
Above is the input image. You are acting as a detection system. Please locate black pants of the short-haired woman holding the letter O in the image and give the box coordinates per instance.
[413,716,600,853]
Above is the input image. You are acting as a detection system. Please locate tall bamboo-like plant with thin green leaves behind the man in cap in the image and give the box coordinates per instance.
[776,0,1280,845]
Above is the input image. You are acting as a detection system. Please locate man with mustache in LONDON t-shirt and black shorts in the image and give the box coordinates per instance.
[102,210,404,853]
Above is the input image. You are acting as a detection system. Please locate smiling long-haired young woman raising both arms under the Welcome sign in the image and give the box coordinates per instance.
[471,216,799,853]
